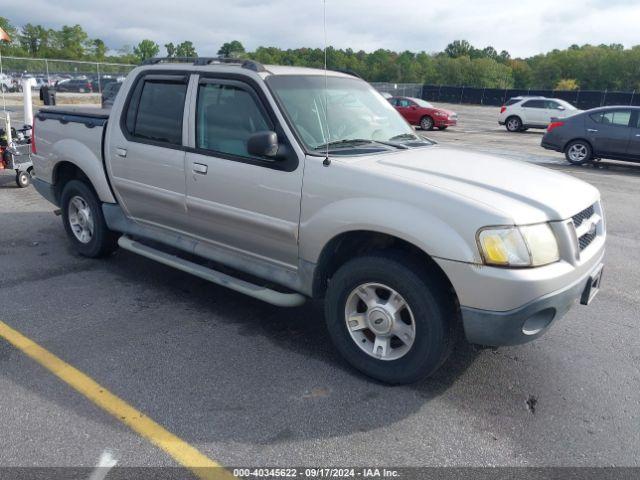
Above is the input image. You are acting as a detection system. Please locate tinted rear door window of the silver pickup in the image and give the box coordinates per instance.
[125,79,187,145]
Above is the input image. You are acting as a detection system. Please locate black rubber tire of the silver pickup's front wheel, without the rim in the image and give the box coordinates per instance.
[325,252,456,384]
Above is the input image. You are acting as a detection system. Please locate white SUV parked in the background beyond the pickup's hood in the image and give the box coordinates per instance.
[498,97,582,132]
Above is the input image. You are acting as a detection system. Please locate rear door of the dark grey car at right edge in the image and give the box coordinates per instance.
[585,108,632,156]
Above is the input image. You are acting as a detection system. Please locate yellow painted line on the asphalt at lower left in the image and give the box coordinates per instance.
[0,321,236,480]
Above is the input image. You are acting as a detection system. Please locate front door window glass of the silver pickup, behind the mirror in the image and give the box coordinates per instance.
[196,82,273,157]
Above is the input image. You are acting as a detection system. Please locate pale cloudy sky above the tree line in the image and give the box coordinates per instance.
[0,0,640,57]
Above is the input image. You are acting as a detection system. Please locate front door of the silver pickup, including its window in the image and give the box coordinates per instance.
[186,77,303,268]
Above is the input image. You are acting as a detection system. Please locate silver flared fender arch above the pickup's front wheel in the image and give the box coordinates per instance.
[300,197,480,263]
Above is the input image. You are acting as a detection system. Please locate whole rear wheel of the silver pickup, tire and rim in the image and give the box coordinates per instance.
[60,180,118,258]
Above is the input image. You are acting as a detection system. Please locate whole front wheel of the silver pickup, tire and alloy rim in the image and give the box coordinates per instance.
[325,254,454,384]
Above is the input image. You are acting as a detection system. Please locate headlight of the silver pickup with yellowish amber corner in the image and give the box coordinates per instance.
[478,223,560,267]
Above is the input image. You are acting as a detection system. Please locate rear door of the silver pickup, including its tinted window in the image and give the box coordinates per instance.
[107,72,188,230]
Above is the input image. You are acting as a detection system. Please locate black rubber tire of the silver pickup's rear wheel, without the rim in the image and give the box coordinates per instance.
[60,180,118,258]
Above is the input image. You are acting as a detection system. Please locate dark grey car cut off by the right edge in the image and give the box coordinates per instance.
[542,107,640,165]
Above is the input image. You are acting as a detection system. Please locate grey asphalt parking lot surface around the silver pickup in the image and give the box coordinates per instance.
[0,101,640,475]
